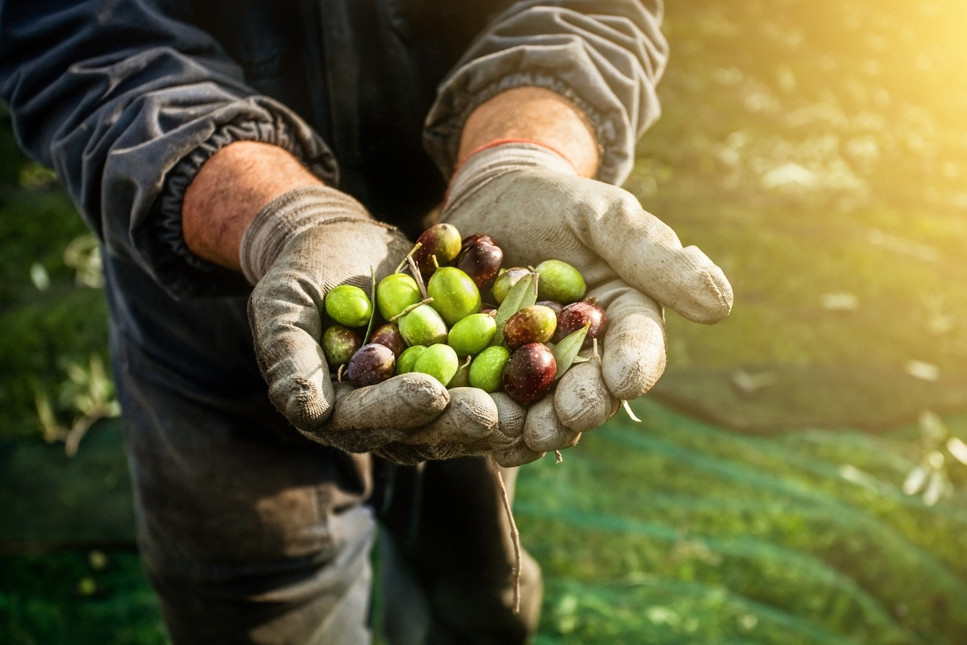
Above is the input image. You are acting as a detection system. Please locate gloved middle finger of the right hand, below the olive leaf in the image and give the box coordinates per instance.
[554,359,621,432]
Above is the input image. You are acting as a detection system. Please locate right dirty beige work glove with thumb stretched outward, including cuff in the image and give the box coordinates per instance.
[441,142,732,465]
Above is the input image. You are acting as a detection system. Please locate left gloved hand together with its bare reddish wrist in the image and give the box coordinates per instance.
[183,143,507,463]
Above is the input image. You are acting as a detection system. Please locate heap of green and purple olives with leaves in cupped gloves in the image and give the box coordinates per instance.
[321,223,608,405]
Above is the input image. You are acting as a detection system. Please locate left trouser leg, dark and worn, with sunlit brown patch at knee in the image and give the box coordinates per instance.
[105,257,375,645]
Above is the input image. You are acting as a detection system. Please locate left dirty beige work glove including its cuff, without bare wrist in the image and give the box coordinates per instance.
[240,186,497,463]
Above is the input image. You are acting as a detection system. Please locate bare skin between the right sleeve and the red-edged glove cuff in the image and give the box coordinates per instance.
[458,87,600,177]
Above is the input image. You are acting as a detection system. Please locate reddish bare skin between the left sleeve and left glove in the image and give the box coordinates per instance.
[181,141,323,271]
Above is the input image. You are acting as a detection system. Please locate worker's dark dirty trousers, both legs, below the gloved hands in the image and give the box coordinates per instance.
[104,254,540,645]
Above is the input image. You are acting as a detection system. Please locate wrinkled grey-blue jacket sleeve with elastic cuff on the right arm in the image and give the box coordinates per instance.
[424,0,668,184]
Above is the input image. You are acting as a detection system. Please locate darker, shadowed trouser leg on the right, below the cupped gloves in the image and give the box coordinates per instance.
[380,457,542,645]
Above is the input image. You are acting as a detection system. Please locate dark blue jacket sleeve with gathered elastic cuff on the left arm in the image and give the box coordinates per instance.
[0,0,336,297]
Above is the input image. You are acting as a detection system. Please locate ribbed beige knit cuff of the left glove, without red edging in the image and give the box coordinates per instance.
[239,186,372,285]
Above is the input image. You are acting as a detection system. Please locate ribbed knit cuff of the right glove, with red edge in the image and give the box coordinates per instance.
[445,139,578,209]
